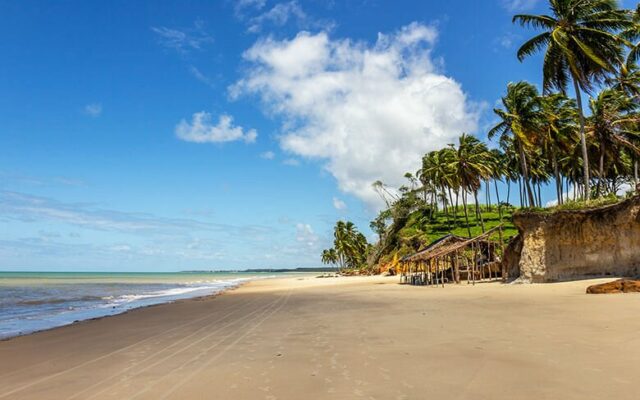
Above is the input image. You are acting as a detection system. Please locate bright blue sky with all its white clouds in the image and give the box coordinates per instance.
[0,0,630,271]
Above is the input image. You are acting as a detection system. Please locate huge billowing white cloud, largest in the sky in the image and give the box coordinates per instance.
[230,23,479,206]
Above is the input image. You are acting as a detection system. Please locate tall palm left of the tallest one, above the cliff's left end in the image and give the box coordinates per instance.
[488,81,540,207]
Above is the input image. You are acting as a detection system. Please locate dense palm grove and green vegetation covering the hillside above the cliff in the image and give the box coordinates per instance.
[323,0,640,272]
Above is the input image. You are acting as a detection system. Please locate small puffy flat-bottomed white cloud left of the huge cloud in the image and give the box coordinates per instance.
[176,111,258,143]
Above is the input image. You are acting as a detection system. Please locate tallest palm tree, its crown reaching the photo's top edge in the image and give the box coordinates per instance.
[513,0,634,200]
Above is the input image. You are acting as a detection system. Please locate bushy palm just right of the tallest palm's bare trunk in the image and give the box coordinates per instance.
[587,89,640,196]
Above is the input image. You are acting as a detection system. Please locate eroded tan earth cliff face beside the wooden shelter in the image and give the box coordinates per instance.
[504,196,640,282]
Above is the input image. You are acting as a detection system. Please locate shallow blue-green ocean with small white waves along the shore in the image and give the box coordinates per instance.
[0,271,274,339]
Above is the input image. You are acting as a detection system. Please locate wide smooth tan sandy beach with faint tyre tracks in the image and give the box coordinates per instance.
[0,277,640,400]
